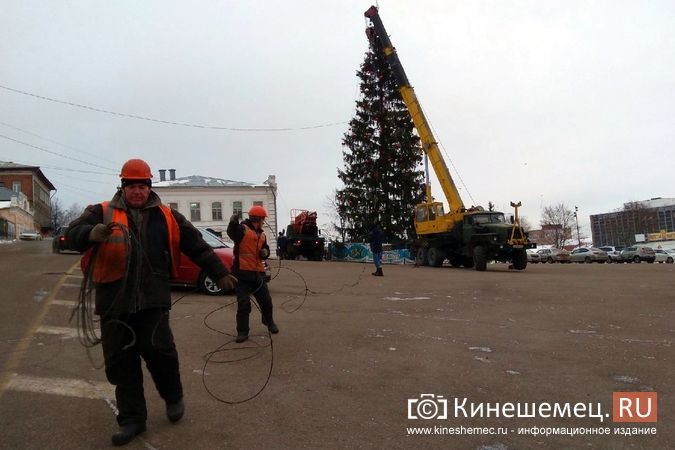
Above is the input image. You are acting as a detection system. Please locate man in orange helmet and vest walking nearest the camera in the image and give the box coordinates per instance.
[67,159,236,445]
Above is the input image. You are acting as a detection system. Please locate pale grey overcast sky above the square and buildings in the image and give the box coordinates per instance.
[0,0,675,234]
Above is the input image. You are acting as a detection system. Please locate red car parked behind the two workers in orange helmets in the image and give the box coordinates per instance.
[171,227,271,295]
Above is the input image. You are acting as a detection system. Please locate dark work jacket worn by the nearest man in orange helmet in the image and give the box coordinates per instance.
[67,191,229,317]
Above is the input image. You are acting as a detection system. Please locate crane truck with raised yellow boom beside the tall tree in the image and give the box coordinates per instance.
[365,6,536,271]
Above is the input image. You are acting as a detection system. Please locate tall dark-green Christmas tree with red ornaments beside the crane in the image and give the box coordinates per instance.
[335,44,424,242]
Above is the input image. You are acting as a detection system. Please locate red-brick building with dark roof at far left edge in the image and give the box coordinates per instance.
[0,161,56,234]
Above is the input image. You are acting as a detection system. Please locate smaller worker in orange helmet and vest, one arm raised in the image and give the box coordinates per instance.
[227,205,279,342]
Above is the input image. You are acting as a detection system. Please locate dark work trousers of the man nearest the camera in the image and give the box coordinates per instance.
[101,308,183,425]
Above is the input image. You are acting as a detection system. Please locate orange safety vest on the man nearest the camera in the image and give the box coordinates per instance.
[80,202,180,283]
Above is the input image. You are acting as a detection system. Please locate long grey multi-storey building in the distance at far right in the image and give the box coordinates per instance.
[591,197,675,247]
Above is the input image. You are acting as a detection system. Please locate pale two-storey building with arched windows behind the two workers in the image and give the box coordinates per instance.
[152,169,278,250]
